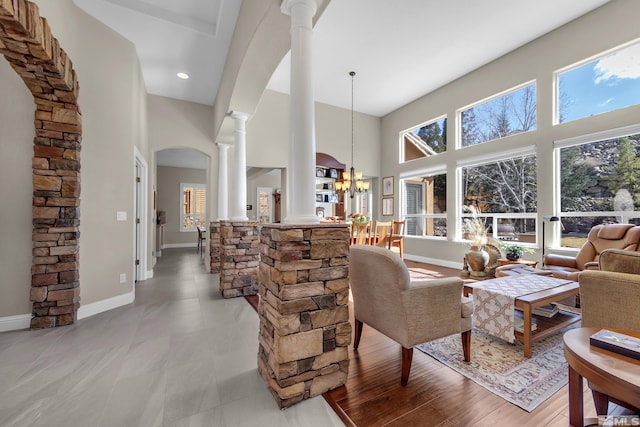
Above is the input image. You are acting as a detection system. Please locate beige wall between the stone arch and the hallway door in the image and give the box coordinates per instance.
[36,0,146,310]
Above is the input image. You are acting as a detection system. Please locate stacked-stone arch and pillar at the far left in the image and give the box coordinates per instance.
[0,0,82,328]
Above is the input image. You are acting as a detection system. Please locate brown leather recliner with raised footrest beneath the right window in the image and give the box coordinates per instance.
[544,224,640,282]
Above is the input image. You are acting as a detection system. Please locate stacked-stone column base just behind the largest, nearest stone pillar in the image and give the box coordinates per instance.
[220,221,260,298]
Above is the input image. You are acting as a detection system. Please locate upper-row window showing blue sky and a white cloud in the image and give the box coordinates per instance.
[556,43,640,123]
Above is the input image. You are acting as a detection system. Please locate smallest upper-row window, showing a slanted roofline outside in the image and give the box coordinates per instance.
[400,117,447,163]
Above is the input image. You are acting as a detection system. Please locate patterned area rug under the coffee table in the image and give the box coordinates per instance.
[416,328,568,412]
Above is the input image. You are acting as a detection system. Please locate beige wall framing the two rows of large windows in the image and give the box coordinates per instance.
[381,1,640,264]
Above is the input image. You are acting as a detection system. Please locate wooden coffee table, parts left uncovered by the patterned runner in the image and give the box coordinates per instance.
[463,279,581,358]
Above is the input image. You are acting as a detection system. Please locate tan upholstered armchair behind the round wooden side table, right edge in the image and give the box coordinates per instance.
[579,249,640,414]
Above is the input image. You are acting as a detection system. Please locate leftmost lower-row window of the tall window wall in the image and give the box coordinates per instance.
[402,173,447,237]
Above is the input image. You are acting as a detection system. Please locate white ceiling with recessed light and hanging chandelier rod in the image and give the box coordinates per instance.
[74,0,608,116]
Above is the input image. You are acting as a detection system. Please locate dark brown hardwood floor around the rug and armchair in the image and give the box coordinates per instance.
[250,261,623,427]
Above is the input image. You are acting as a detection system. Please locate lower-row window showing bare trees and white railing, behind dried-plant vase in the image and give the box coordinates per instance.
[461,153,537,243]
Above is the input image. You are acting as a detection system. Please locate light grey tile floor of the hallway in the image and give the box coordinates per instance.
[0,248,343,427]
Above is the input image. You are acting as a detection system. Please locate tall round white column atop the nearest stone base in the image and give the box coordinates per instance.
[281,0,322,224]
